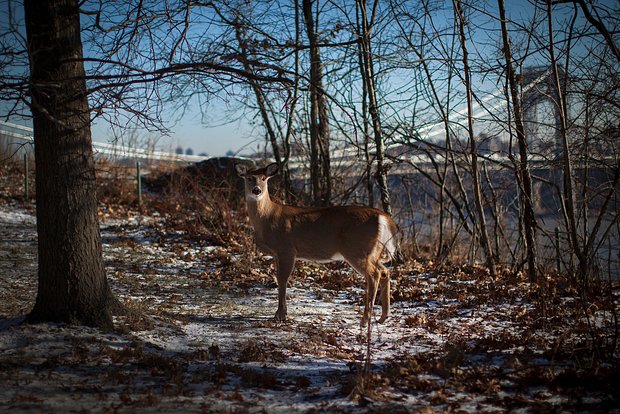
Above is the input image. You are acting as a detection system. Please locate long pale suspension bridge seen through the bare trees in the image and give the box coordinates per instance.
[0,67,614,174]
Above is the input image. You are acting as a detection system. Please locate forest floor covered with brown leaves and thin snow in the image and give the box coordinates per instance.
[0,163,620,413]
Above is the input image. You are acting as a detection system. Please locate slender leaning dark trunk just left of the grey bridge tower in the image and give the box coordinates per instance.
[497,0,538,282]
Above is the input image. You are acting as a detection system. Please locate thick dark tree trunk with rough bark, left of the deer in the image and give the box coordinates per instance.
[24,0,116,329]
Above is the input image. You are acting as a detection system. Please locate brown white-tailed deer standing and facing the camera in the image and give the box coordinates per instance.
[235,163,396,326]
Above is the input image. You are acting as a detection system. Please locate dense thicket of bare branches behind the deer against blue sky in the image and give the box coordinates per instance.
[0,0,620,287]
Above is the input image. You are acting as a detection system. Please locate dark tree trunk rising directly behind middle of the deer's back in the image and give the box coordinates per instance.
[302,0,331,205]
